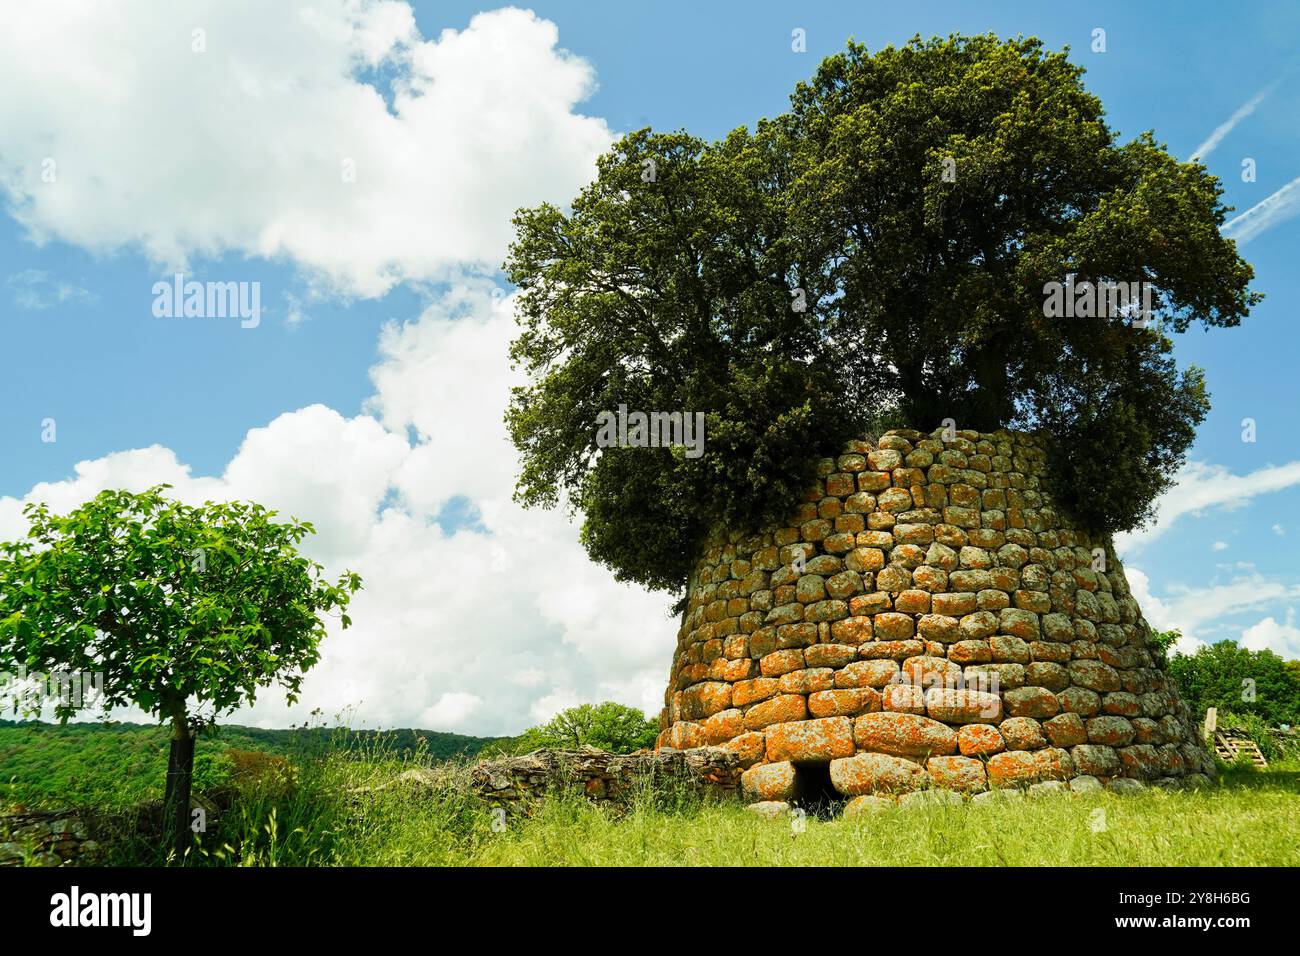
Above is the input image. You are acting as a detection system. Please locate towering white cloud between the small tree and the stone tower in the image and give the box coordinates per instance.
[0,285,676,735]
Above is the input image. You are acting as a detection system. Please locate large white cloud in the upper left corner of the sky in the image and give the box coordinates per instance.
[0,0,611,297]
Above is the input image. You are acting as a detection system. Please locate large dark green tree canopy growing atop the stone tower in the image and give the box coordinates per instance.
[506,35,1260,591]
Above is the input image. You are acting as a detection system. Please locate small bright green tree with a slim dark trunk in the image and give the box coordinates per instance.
[0,485,361,861]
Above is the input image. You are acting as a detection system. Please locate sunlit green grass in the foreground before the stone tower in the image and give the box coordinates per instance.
[301,770,1300,866]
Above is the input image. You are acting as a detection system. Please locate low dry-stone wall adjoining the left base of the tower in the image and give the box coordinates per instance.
[471,747,742,806]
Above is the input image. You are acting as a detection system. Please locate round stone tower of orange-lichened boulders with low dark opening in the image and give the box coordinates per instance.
[657,429,1214,804]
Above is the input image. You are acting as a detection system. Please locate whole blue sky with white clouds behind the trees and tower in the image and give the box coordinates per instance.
[0,0,1300,732]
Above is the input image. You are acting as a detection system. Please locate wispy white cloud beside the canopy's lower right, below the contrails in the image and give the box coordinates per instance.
[1115,462,1300,555]
